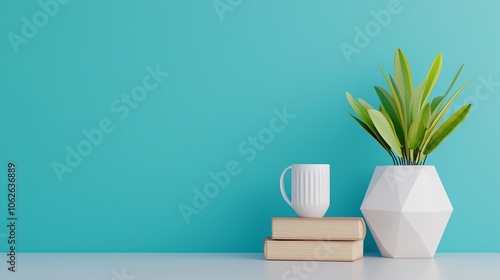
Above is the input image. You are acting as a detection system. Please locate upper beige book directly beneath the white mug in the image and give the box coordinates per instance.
[272,217,366,240]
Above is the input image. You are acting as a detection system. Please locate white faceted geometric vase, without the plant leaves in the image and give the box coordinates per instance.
[361,165,453,258]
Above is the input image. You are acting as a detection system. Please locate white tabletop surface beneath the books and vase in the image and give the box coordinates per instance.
[0,253,500,280]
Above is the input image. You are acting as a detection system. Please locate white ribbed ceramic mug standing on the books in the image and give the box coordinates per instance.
[280,164,330,218]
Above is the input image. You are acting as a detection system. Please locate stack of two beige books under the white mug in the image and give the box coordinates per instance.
[264,218,366,261]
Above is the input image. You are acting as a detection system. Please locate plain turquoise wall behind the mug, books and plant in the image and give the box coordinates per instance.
[0,0,500,252]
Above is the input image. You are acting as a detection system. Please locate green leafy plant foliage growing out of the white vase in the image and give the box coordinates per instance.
[346,49,471,165]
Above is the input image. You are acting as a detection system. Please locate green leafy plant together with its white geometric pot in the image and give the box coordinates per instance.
[346,49,471,258]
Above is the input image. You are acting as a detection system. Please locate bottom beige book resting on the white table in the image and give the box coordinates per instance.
[264,238,363,262]
